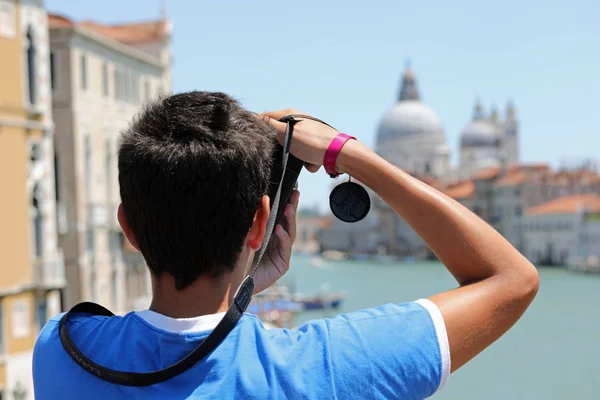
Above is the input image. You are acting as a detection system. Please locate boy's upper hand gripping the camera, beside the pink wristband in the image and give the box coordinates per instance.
[259,108,339,172]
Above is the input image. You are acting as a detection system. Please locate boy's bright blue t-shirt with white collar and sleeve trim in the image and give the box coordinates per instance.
[33,300,450,400]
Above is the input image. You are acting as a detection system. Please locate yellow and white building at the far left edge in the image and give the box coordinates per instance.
[0,0,65,399]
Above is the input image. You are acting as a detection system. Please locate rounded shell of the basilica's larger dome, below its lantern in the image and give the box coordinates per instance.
[377,100,444,143]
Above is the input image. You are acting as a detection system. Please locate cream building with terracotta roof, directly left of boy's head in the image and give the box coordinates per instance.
[50,15,172,313]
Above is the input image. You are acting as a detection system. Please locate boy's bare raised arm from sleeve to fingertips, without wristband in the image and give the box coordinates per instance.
[265,110,539,371]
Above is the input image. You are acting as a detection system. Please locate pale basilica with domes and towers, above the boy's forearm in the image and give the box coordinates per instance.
[376,63,519,182]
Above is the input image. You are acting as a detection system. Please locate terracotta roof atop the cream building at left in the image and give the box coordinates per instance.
[48,13,167,44]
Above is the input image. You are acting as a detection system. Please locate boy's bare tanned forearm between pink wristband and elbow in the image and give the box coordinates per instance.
[338,141,533,285]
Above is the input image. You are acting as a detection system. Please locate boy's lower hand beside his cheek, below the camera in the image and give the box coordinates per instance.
[254,190,300,294]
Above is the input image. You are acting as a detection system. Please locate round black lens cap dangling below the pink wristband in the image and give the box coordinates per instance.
[329,182,371,223]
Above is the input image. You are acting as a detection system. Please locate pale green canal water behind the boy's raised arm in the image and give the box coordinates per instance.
[284,255,600,400]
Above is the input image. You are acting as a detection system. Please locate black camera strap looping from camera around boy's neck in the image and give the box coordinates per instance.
[58,115,329,386]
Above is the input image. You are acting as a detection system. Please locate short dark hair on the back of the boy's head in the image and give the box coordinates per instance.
[119,92,274,290]
